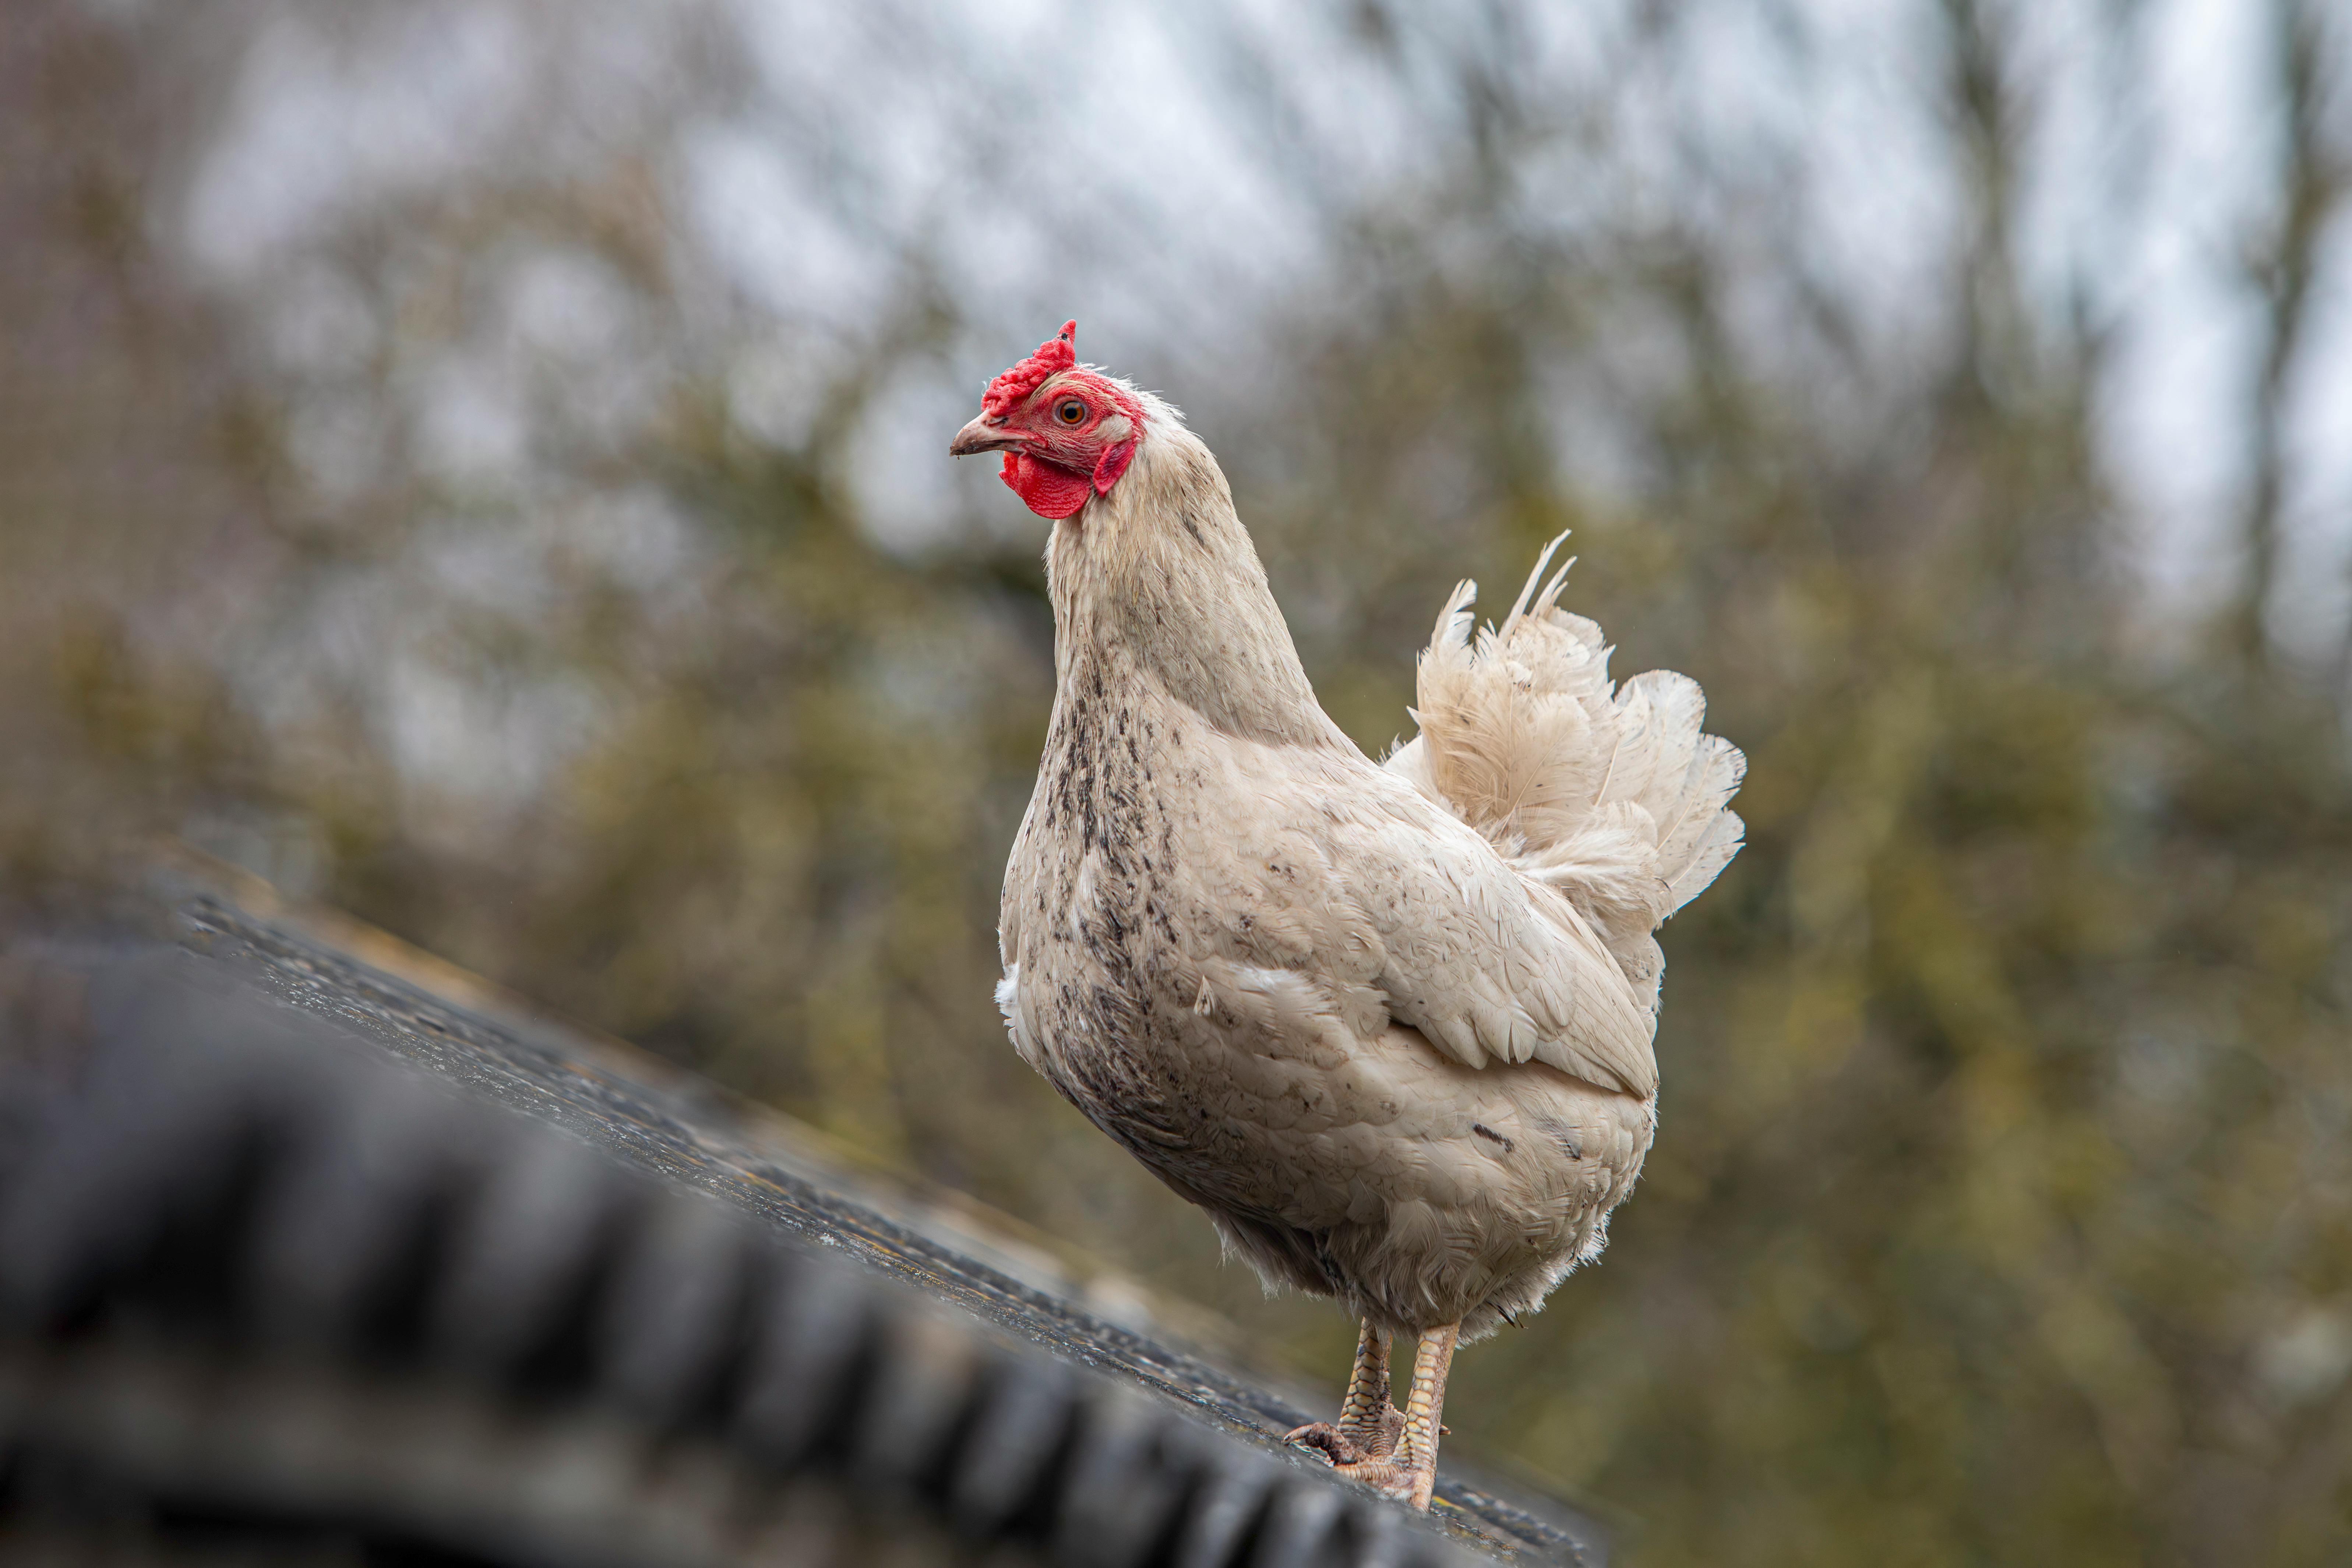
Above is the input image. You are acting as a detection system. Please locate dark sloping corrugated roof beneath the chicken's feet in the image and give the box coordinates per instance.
[0,891,1604,1566]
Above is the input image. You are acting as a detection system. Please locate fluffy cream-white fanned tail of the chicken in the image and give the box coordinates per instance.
[1388,534,1745,983]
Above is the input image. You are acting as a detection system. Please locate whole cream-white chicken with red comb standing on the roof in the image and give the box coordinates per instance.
[950,322,1743,1509]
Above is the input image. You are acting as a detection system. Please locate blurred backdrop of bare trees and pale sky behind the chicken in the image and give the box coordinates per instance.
[0,0,2352,1566]
